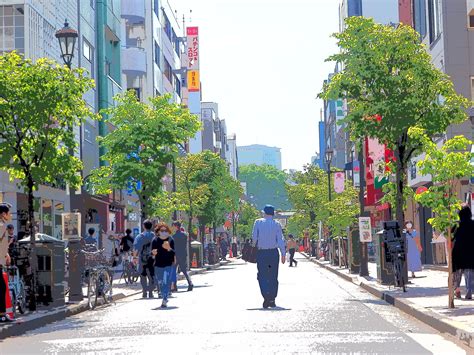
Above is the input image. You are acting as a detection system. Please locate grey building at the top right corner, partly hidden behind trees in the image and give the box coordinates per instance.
[400,0,474,264]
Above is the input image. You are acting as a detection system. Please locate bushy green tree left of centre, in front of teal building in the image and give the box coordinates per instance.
[91,91,200,218]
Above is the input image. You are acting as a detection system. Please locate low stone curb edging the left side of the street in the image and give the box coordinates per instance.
[0,260,232,343]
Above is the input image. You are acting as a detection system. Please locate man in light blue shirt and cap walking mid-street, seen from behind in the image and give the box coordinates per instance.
[252,205,286,308]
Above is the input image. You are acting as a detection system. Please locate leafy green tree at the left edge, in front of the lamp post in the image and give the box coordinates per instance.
[0,52,96,309]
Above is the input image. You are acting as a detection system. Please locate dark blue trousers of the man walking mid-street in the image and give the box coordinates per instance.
[257,249,280,300]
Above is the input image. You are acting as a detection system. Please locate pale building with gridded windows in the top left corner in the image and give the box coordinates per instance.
[0,0,79,238]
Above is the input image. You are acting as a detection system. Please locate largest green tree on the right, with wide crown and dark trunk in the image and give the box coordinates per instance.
[320,17,469,227]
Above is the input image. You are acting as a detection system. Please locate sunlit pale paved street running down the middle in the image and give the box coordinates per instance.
[0,257,465,354]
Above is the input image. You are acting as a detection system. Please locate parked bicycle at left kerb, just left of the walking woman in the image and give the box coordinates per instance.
[82,249,113,309]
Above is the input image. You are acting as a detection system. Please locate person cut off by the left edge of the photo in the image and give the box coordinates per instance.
[0,203,12,321]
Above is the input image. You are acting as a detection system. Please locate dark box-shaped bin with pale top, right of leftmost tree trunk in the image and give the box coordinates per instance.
[19,233,65,307]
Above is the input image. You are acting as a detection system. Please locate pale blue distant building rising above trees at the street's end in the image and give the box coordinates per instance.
[237,144,282,170]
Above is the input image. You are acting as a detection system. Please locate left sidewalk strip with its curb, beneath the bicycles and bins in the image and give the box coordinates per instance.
[0,259,235,340]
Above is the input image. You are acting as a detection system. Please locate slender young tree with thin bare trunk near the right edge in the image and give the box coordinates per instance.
[409,127,474,308]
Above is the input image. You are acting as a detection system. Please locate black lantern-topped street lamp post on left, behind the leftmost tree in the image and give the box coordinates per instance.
[55,20,84,301]
